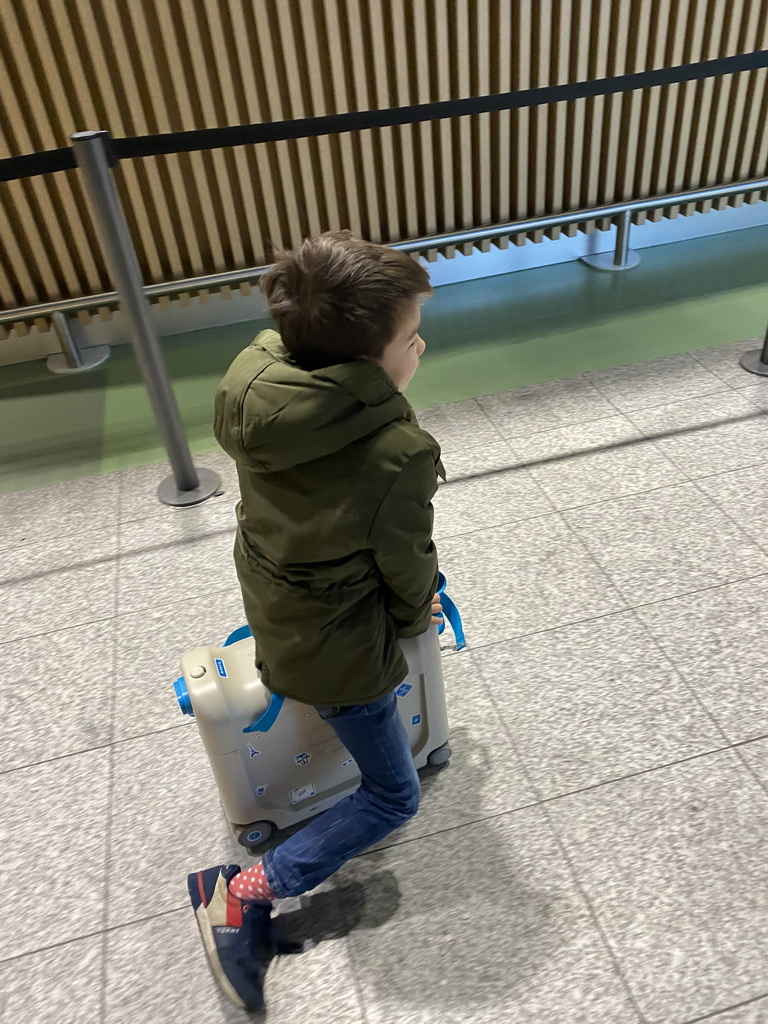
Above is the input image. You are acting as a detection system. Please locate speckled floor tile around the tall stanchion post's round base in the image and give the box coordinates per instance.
[119,450,240,522]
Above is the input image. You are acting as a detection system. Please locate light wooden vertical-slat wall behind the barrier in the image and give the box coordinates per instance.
[0,0,768,332]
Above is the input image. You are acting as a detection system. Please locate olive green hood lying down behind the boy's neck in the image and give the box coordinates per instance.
[214,331,414,473]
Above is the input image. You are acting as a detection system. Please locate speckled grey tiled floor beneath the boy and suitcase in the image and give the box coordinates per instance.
[0,344,768,1024]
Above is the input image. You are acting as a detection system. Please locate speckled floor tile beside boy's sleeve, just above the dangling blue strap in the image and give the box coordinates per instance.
[440,515,624,646]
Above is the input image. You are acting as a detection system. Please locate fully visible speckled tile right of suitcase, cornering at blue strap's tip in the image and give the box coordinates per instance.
[474,612,725,798]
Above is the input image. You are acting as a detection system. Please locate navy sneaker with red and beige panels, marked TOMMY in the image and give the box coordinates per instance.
[186,864,301,1011]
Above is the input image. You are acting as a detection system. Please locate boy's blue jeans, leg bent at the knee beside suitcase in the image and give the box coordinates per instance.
[262,693,421,897]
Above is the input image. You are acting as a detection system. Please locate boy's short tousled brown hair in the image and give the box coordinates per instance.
[261,231,432,370]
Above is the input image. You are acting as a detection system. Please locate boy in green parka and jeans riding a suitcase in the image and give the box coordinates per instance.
[187,231,442,1010]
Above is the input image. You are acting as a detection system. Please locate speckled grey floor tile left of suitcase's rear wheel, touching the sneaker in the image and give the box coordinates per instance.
[109,728,245,925]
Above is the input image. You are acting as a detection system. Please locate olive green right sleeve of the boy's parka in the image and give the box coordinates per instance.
[369,452,437,638]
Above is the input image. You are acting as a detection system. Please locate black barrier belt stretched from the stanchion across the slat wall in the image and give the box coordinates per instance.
[0,50,768,181]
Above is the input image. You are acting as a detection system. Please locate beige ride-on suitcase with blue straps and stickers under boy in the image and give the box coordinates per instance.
[174,577,465,849]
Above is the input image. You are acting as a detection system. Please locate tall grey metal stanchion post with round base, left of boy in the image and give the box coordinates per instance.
[72,131,219,505]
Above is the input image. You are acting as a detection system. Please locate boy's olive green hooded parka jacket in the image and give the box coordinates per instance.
[215,331,442,707]
